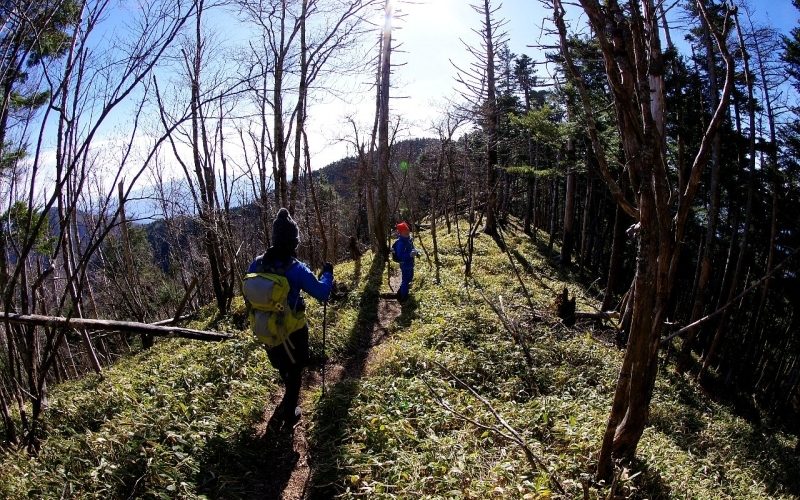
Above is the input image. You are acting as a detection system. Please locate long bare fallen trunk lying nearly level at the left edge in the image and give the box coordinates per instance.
[0,312,233,342]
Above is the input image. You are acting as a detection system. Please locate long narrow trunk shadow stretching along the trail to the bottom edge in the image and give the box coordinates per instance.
[308,256,384,498]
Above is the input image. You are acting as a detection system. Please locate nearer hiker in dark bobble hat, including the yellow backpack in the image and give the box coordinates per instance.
[243,208,333,427]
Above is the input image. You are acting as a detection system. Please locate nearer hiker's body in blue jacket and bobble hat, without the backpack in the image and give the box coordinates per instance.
[247,208,333,427]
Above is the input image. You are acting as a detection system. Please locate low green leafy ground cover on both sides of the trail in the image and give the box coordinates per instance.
[0,224,800,499]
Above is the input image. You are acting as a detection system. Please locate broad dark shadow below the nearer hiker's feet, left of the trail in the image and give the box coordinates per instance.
[196,404,299,499]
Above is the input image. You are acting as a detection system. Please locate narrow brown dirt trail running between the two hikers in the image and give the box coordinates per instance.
[254,269,402,500]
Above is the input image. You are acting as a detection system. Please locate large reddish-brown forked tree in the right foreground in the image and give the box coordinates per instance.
[549,0,734,479]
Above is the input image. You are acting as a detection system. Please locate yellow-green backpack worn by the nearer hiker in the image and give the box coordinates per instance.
[242,273,306,359]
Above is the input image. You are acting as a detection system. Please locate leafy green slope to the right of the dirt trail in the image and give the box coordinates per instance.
[304,228,800,498]
